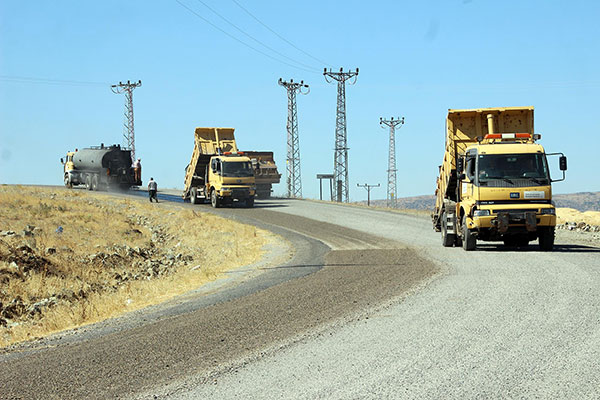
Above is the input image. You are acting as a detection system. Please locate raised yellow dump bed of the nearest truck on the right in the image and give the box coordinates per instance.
[433,107,533,229]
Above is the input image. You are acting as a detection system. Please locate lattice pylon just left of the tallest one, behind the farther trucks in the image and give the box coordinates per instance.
[278,78,310,197]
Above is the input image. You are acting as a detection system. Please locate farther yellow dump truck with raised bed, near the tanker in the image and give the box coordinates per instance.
[183,128,256,208]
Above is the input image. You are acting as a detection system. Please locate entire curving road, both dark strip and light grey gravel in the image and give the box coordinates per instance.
[0,193,600,399]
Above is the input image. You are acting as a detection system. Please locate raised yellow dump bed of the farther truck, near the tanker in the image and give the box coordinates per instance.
[183,128,238,198]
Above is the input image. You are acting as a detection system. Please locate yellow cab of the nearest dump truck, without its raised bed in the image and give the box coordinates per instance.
[457,134,566,250]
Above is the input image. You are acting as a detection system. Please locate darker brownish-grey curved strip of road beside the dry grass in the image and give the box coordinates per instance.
[0,196,439,399]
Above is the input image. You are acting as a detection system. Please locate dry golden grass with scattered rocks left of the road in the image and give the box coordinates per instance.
[0,185,273,347]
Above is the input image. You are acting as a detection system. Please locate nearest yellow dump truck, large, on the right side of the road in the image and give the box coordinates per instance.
[432,107,567,251]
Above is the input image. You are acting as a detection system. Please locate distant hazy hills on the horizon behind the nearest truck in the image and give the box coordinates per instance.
[357,192,600,212]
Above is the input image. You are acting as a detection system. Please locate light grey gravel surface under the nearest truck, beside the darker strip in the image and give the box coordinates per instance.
[162,201,600,399]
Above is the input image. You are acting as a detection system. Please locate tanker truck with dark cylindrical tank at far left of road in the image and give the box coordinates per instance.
[60,144,142,190]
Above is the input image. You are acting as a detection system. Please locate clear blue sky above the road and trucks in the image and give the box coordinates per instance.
[0,0,600,201]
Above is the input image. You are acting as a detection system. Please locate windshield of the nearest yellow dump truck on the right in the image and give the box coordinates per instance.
[477,154,549,186]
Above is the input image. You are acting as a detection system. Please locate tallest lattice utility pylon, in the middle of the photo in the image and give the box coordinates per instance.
[323,68,358,203]
